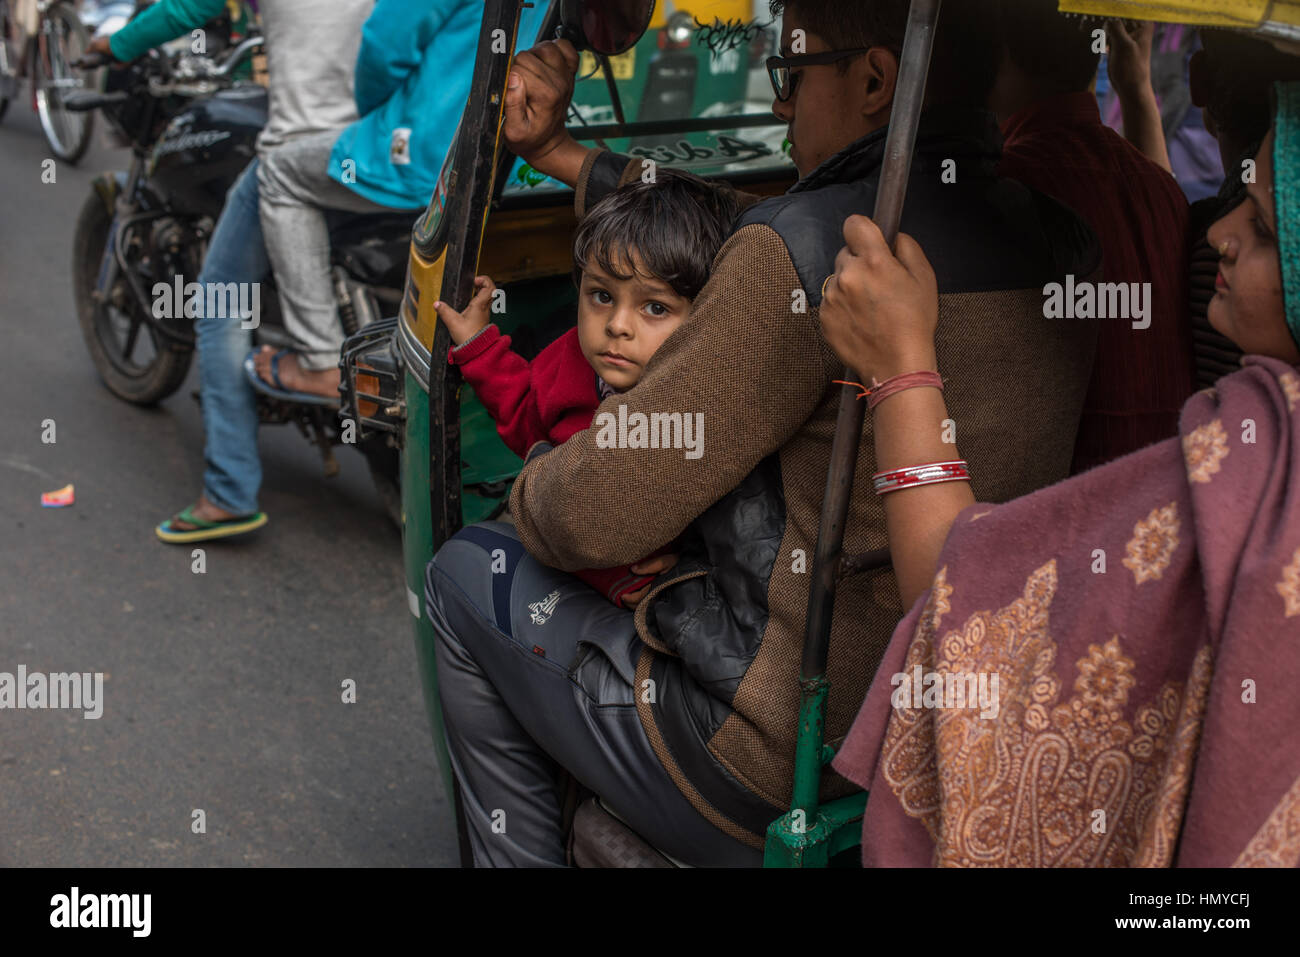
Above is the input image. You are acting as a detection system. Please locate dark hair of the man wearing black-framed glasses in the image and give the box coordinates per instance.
[768,0,1000,108]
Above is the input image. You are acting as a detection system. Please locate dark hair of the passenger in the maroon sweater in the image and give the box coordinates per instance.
[997,0,1104,94]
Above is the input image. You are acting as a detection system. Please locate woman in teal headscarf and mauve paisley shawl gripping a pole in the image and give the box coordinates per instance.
[820,83,1300,867]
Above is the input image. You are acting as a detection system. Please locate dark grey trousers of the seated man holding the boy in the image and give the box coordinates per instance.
[425,521,762,867]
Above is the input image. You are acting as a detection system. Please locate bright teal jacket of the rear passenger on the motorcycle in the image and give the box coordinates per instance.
[329,0,549,209]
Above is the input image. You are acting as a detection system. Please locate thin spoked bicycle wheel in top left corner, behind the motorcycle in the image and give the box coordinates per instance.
[33,4,95,163]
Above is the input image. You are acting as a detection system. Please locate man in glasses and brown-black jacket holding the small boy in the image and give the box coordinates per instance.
[428,0,1100,866]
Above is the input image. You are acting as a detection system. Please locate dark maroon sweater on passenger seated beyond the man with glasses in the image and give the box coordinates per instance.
[998,92,1195,472]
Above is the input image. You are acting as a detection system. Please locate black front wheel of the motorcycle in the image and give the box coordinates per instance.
[73,192,194,406]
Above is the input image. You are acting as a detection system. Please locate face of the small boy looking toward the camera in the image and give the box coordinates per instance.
[577,256,690,391]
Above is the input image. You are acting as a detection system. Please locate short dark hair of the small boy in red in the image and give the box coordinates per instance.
[573,166,740,299]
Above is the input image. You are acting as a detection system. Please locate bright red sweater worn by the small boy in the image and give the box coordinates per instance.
[447,325,658,606]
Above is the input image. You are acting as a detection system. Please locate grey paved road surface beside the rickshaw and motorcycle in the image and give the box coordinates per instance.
[0,103,455,866]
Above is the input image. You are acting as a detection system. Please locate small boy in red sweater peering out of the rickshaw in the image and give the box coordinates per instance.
[434,168,740,607]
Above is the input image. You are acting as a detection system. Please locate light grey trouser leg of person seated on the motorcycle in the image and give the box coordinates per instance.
[257,130,393,371]
